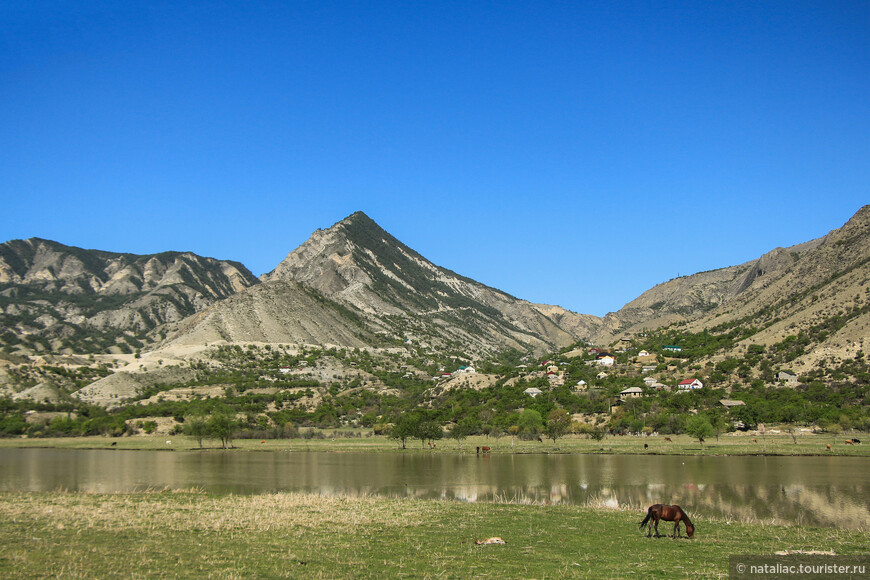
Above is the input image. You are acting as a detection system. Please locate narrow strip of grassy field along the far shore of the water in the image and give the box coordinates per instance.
[0,431,870,457]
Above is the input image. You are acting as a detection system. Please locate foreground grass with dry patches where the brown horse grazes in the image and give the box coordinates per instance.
[0,491,870,578]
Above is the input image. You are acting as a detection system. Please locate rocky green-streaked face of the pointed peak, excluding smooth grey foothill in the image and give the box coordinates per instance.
[252,212,600,354]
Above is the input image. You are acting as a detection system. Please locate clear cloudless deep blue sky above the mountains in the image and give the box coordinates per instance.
[0,0,870,315]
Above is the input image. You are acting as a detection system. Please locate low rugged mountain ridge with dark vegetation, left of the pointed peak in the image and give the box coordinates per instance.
[0,238,259,352]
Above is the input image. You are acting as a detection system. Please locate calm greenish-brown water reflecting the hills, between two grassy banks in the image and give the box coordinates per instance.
[0,449,870,529]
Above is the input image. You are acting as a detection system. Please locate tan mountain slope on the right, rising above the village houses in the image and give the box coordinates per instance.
[605,205,870,371]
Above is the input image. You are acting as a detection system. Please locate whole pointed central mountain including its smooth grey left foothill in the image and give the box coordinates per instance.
[173,212,600,356]
